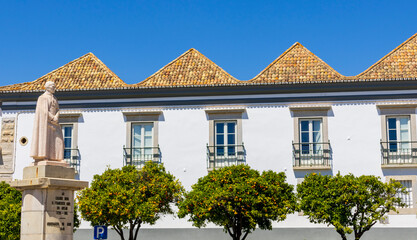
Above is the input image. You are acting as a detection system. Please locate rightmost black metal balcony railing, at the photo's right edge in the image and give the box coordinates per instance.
[381,141,417,165]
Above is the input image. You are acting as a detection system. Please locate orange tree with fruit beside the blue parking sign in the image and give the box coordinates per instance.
[77,162,183,240]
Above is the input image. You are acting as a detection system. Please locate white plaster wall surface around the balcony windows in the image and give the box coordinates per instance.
[3,102,417,228]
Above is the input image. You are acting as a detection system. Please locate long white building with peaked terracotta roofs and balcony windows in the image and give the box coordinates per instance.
[0,35,417,239]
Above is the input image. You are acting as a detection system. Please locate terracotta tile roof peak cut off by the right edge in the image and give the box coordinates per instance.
[355,33,417,79]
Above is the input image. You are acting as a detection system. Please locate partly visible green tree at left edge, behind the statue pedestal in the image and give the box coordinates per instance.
[0,182,22,240]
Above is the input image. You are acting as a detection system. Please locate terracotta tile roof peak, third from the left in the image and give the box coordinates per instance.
[249,42,344,83]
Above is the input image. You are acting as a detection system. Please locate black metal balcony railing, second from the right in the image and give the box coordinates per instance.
[292,142,332,167]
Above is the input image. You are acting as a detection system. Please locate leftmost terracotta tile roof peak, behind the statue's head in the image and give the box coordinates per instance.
[0,53,128,92]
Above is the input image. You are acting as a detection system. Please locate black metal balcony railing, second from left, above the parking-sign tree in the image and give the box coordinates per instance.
[123,146,162,168]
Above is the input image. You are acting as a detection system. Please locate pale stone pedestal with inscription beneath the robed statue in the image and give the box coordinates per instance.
[11,165,88,240]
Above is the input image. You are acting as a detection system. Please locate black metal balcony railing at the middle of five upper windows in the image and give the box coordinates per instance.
[207,144,246,169]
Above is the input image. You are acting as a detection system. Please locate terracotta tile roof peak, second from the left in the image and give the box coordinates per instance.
[133,48,240,87]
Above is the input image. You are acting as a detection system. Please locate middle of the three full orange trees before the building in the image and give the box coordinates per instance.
[178,165,296,240]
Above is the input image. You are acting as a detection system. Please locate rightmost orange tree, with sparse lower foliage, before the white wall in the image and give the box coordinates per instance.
[297,173,405,240]
